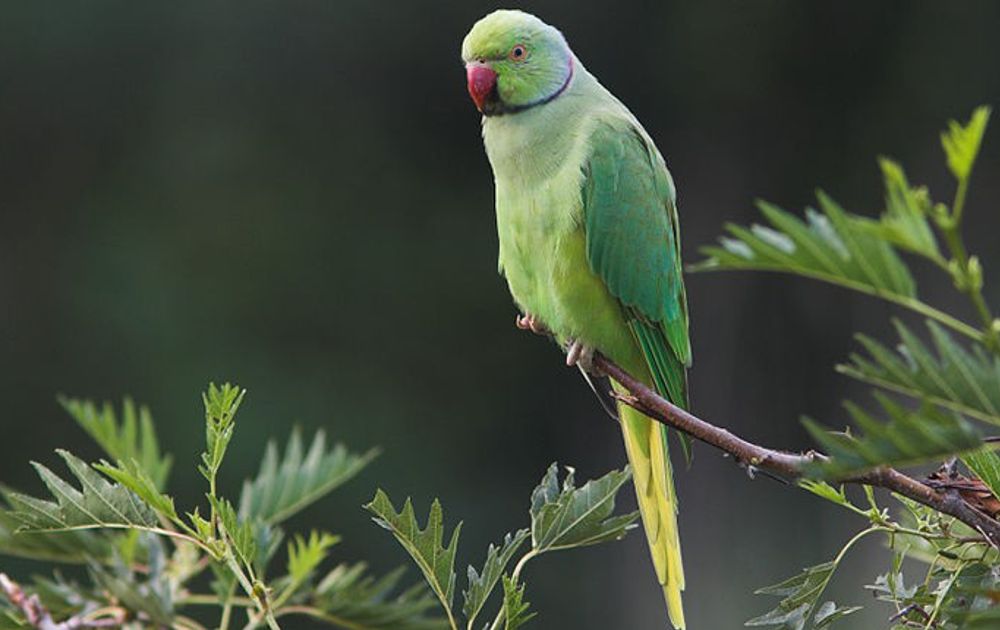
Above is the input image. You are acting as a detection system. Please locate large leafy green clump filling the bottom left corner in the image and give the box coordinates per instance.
[0,384,443,630]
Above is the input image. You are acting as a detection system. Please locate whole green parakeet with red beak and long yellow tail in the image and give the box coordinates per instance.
[462,10,691,628]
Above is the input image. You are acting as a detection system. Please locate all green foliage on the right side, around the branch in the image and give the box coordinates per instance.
[697,107,1000,630]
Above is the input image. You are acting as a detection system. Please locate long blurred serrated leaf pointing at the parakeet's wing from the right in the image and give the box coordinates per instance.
[694,192,916,302]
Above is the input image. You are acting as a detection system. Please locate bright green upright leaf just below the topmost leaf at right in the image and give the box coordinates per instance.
[860,163,944,264]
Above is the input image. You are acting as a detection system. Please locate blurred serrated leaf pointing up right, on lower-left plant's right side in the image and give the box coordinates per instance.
[240,429,378,523]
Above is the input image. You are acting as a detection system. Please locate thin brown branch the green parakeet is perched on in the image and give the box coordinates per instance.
[593,354,1000,547]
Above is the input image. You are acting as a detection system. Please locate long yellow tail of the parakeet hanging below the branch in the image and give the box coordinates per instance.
[612,383,685,630]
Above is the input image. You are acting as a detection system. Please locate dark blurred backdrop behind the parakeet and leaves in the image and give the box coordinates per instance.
[0,0,1000,629]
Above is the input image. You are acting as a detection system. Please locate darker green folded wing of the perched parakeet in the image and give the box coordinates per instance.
[582,119,691,406]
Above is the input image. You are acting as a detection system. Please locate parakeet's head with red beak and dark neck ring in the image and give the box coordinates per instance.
[462,10,574,116]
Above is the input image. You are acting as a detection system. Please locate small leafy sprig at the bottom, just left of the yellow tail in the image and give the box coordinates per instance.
[365,464,639,630]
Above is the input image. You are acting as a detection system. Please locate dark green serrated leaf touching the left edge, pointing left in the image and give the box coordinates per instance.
[7,450,159,532]
